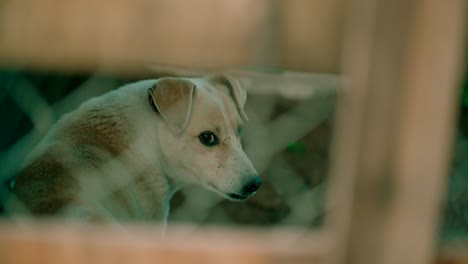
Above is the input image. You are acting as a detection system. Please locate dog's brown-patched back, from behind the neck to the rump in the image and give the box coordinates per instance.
[10,85,146,219]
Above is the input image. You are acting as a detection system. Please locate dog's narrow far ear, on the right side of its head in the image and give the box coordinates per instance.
[208,74,248,120]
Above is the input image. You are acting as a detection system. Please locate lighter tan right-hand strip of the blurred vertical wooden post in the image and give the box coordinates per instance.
[384,0,467,263]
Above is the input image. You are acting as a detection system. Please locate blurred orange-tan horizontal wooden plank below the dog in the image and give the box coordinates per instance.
[0,222,328,264]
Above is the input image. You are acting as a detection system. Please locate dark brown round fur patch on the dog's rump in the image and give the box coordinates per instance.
[13,153,77,215]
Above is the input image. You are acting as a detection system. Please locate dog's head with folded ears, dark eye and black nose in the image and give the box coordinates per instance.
[148,75,262,200]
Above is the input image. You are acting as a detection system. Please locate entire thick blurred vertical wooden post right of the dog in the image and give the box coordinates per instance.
[329,0,465,264]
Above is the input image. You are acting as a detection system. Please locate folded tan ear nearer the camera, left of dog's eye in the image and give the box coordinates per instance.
[148,78,195,134]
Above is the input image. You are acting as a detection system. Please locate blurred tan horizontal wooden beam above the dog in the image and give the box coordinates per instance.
[0,0,343,73]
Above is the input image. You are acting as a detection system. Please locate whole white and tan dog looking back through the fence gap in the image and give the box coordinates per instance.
[8,75,262,224]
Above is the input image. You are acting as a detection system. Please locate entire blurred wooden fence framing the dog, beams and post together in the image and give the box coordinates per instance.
[0,0,468,264]
